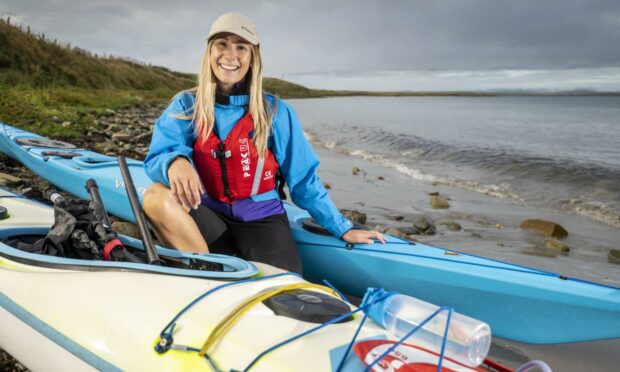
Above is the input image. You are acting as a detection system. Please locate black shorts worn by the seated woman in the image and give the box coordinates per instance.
[189,205,302,274]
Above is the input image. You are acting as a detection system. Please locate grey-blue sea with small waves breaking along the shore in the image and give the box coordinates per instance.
[292,96,620,228]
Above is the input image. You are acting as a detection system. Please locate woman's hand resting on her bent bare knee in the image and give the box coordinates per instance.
[168,156,204,209]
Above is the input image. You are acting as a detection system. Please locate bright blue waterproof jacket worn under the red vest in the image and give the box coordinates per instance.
[144,92,353,237]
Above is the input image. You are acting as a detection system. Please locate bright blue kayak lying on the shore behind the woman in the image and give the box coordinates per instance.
[0,123,620,344]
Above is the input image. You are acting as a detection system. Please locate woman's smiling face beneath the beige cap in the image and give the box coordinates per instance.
[209,34,252,93]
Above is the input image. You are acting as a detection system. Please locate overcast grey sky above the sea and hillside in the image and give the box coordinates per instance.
[0,0,620,91]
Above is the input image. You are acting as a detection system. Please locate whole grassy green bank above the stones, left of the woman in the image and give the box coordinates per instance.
[0,20,195,138]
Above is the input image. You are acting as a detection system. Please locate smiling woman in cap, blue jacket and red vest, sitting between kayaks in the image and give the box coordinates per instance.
[144,13,385,272]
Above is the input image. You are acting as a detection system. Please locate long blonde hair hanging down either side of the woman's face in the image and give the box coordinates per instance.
[183,38,277,157]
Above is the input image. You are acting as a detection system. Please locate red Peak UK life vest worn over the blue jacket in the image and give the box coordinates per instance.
[193,112,278,203]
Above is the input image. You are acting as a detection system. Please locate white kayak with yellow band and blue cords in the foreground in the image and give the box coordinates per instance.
[0,190,490,371]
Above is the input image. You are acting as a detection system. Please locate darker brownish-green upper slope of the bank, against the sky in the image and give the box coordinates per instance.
[0,19,195,90]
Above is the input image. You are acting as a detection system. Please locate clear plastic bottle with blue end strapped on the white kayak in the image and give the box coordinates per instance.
[362,288,491,367]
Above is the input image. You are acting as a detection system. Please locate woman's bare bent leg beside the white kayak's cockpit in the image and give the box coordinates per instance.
[144,182,209,253]
